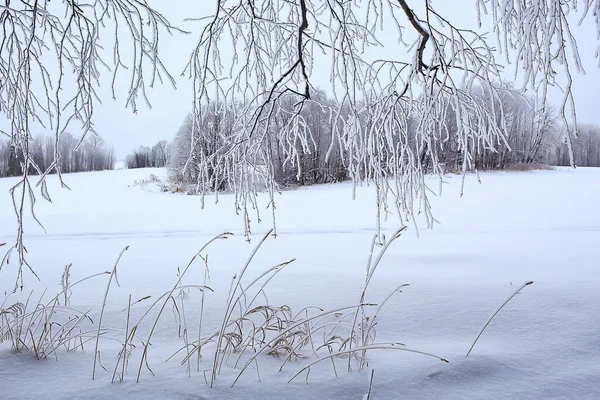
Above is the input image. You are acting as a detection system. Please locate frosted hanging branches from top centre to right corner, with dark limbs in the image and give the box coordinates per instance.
[183,0,599,236]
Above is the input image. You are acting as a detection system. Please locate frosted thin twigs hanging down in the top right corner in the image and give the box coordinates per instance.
[477,0,600,165]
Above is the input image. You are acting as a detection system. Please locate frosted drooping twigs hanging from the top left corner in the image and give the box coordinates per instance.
[0,0,183,286]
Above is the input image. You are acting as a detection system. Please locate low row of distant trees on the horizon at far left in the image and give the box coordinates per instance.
[0,133,116,177]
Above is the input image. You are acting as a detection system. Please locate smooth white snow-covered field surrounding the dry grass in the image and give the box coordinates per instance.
[0,168,600,399]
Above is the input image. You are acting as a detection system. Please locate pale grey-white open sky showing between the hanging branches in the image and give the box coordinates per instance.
[2,0,600,158]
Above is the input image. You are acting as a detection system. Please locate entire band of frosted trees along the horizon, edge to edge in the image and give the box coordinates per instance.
[0,90,600,183]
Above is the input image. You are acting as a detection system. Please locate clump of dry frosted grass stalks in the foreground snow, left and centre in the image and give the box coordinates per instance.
[0,231,448,387]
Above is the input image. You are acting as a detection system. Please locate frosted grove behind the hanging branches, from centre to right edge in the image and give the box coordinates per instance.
[166,87,600,190]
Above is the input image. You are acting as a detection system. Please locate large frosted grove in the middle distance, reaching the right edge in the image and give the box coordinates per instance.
[164,85,600,190]
